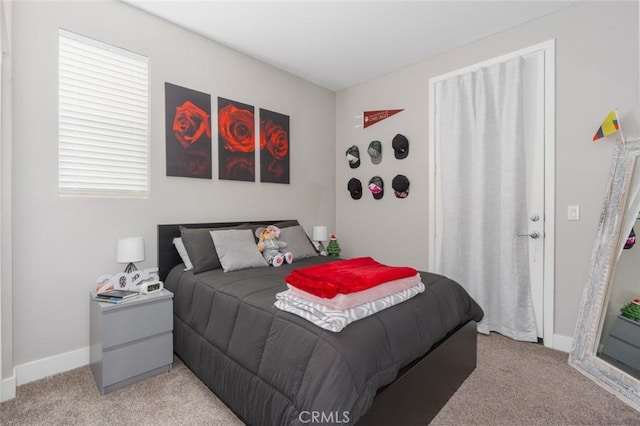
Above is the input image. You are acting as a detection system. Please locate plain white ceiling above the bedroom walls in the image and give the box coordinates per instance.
[122,0,579,91]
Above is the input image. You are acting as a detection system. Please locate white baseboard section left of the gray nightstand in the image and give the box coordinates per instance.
[15,346,89,386]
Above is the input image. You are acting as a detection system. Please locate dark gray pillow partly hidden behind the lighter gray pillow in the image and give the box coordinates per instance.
[180,224,249,274]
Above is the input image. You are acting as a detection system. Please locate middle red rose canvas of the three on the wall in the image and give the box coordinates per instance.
[218,98,256,182]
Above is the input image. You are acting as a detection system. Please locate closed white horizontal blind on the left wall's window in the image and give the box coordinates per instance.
[58,30,149,196]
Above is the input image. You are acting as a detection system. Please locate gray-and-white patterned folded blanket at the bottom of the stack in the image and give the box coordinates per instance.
[275,282,424,333]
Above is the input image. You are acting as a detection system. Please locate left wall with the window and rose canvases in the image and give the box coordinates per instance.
[2,1,335,384]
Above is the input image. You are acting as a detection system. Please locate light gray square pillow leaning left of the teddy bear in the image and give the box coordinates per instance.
[209,229,267,272]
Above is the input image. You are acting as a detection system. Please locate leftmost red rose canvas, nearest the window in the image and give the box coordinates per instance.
[164,83,211,179]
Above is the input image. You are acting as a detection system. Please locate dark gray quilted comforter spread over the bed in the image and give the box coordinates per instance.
[165,257,483,425]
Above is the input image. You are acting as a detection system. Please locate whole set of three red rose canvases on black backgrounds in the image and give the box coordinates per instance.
[165,83,290,184]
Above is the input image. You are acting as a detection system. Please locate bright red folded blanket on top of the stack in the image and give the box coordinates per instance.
[285,257,418,299]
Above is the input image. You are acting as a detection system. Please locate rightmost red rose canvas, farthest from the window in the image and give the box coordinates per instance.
[260,108,290,183]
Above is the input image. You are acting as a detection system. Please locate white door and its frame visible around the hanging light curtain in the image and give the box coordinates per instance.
[429,41,554,346]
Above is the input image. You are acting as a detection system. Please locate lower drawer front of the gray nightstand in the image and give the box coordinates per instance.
[102,333,173,387]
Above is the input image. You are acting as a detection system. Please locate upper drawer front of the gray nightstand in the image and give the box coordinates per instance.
[102,299,173,349]
